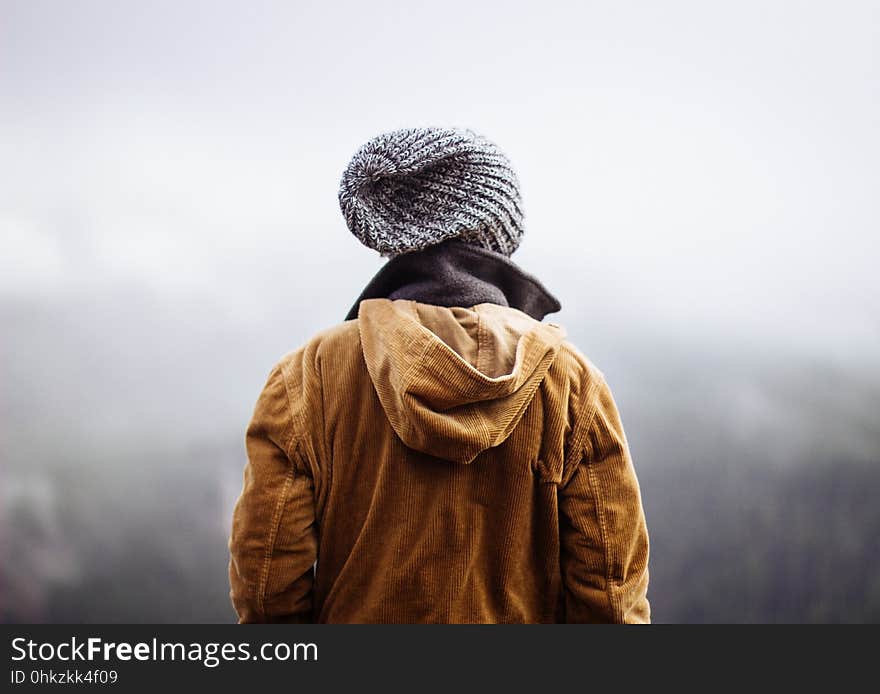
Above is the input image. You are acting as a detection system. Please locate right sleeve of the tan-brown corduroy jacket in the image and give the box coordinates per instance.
[559,378,651,623]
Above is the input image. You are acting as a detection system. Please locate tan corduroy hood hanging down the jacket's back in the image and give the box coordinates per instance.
[358,298,565,464]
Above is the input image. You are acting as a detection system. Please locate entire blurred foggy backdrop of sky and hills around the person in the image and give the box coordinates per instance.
[0,0,880,622]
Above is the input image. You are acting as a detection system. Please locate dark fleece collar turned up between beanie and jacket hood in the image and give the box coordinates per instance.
[345,239,562,320]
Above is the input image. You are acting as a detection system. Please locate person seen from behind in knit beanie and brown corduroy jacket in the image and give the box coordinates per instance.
[229,128,650,623]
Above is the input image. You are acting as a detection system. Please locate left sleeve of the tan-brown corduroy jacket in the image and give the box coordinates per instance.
[229,365,318,623]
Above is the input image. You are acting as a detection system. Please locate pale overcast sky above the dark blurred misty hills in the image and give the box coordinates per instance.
[0,0,880,368]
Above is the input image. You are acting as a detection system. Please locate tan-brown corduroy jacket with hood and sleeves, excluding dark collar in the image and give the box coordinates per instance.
[229,299,650,623]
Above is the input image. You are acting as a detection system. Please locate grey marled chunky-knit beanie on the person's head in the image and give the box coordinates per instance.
[339,128,523,257]
